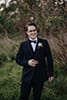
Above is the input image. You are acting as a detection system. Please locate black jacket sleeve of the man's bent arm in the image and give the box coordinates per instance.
[16,43,28,67]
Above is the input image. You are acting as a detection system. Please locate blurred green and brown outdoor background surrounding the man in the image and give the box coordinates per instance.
[0,0,67,100]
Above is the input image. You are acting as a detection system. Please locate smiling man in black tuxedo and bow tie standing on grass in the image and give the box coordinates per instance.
[16,23,53,100]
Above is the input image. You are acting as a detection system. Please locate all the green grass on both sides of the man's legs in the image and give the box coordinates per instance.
[0,61,67,100]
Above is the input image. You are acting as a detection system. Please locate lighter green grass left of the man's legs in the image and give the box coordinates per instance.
[0,62,21,100]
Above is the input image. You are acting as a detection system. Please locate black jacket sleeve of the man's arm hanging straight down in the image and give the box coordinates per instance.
[46,40,53,77]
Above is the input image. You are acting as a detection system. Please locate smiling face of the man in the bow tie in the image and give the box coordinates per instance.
[26,25,37,39]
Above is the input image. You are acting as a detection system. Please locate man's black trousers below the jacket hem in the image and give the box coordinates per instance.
[20,81,44,100]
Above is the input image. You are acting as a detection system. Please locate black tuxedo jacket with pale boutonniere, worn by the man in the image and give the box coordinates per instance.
[16,38,53,84]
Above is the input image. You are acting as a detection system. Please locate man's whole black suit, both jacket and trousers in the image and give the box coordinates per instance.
[16,38,53,100]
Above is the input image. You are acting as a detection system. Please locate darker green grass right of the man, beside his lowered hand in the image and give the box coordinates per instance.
[42,63,67,100]
